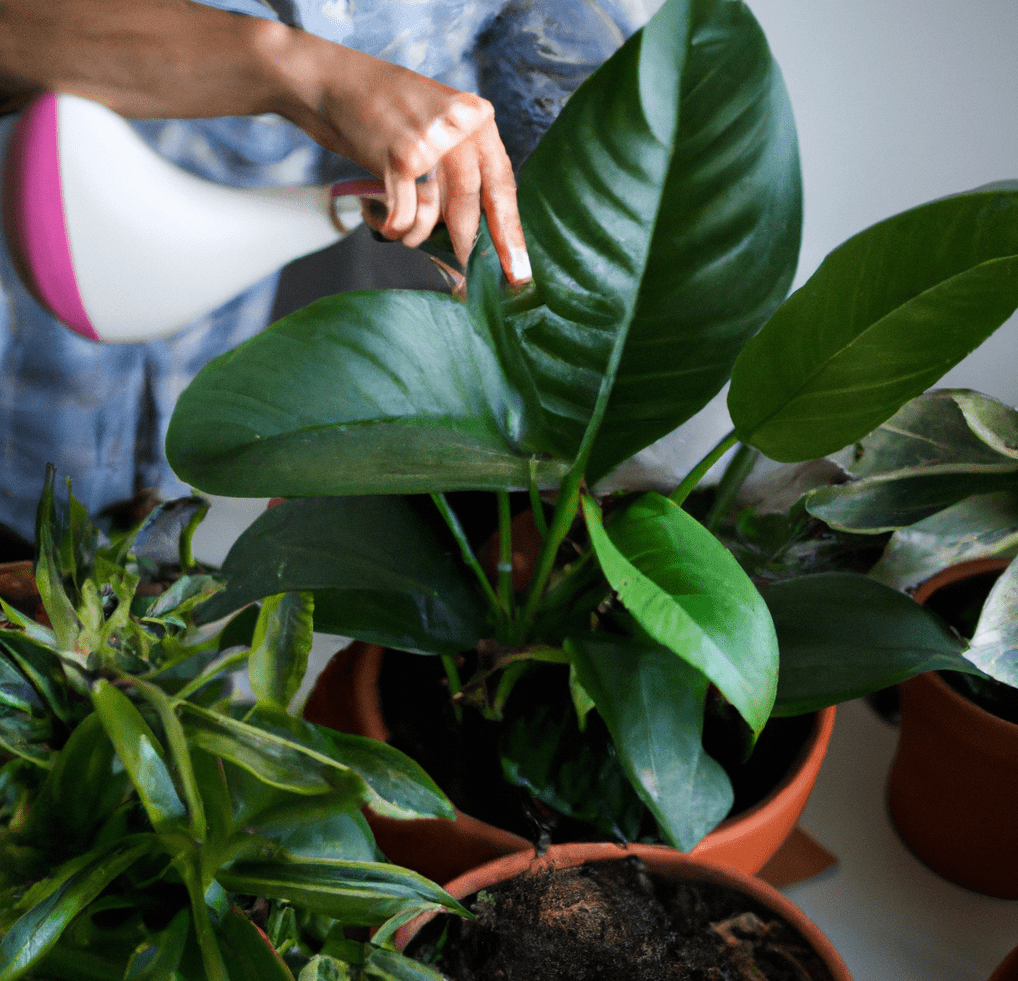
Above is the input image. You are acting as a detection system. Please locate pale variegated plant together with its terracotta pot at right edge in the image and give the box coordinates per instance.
[769,390,1018,898]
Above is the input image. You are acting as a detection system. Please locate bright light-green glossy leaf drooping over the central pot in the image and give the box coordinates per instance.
[583,494,778,734]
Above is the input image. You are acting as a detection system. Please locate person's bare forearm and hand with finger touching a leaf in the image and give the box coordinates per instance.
[0,0,530,283]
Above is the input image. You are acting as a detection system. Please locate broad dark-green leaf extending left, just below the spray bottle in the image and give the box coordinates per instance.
[166,290,560,497]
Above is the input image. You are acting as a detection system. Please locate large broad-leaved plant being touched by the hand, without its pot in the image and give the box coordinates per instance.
[167,0,1018,883]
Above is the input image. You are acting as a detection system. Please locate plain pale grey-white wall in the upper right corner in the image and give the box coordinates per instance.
[747,0,1018,405]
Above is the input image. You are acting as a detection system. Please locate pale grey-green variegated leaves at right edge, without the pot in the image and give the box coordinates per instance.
[789,389,1018,718]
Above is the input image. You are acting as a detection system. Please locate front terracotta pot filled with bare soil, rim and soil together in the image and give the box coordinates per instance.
[397,844,849,981]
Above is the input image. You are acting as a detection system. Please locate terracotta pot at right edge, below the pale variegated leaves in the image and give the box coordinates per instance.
[888,560,1018,899]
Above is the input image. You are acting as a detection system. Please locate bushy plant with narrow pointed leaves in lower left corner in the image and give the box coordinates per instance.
[0,471,468,981]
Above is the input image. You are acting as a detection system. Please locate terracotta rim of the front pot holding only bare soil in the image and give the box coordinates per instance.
[396,843,851,981]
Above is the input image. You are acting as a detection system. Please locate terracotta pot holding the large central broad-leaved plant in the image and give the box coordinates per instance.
[304,643,835,882]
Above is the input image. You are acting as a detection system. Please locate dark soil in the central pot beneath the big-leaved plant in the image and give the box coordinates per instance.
[379,651,815,843]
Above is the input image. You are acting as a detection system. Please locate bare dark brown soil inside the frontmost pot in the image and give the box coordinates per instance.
[407,858,831,981]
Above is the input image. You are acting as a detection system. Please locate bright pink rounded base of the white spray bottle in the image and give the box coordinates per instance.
[5,93,102,341]
